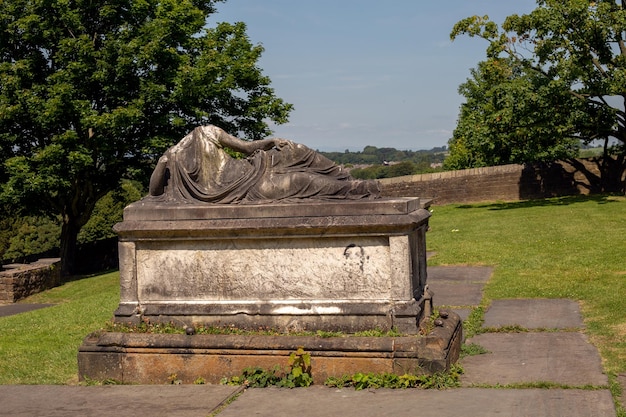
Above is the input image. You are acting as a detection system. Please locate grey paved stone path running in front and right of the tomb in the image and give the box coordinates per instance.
[0,267,626,417]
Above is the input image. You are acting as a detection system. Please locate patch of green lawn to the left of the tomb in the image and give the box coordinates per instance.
[0,272,119,384]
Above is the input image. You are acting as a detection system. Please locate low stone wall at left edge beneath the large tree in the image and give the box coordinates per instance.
[0,258,61,304]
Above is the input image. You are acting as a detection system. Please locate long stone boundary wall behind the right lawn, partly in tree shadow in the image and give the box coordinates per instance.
[380,158,624,204]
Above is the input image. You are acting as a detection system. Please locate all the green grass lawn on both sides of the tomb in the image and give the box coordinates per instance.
[0,196,626,384]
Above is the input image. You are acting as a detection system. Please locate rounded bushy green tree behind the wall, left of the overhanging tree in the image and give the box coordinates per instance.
[444,58,580,169]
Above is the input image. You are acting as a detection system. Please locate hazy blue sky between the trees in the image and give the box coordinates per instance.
[209,0,536,151]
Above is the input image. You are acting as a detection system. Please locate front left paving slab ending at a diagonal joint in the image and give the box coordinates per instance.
[0,385,241,417]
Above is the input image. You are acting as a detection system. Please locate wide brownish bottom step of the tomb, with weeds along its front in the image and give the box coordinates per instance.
[78,312,461,385]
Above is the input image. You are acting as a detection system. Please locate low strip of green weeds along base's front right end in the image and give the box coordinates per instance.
[324,365,463,390]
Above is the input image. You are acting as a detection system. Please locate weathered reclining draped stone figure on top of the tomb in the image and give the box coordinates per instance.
[150,126,379,204]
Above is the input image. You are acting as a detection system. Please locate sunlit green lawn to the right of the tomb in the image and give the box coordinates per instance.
[427,196,626,374]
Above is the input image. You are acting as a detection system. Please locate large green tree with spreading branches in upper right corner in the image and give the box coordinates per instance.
[451,0,626,176]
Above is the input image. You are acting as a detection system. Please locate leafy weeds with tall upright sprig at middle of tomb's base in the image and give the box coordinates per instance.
[222,347,313,388]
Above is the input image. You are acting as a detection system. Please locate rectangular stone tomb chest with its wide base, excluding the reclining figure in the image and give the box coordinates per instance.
[79,198,461,383]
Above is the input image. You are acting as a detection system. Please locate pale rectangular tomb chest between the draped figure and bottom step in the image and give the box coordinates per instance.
[115,198,430,334]
